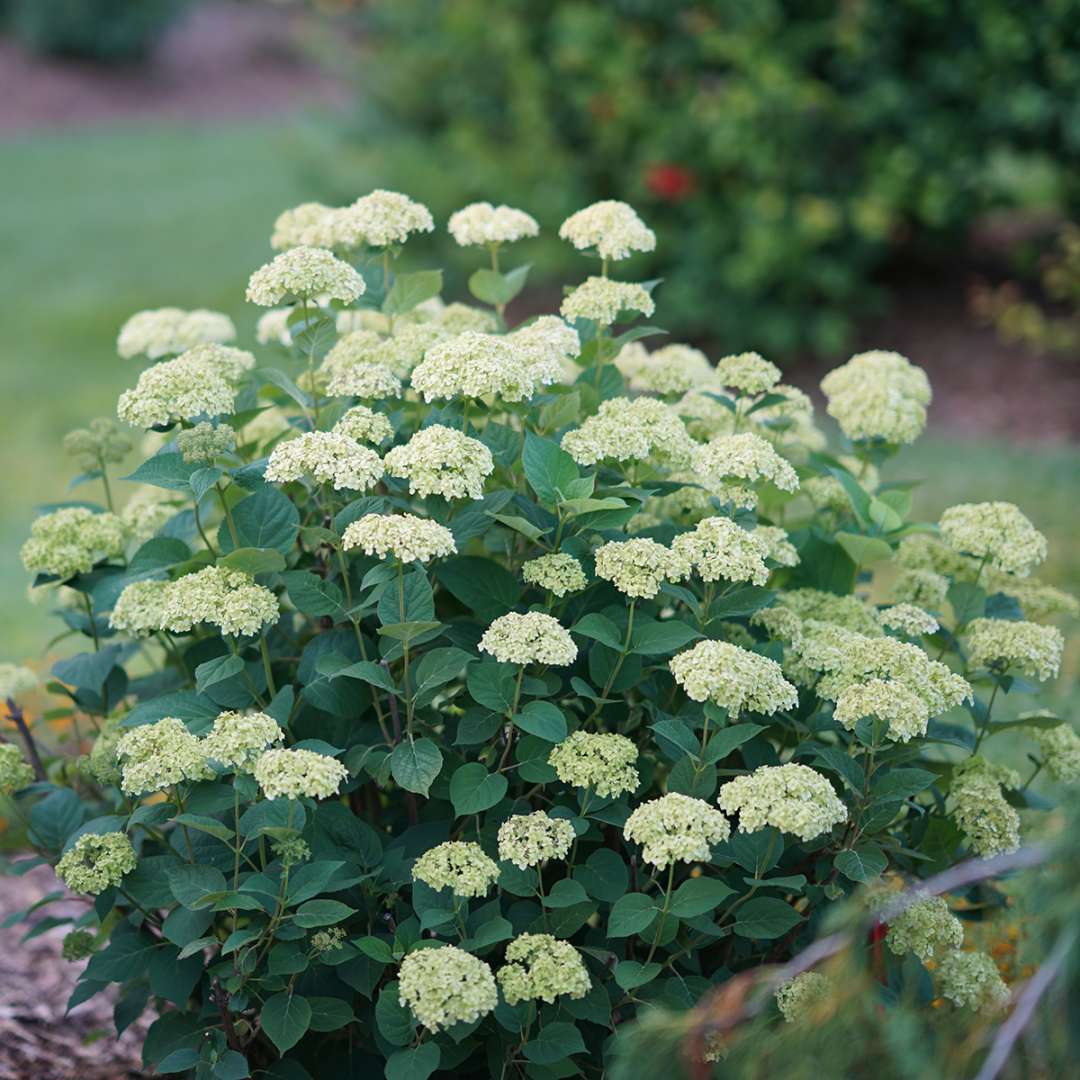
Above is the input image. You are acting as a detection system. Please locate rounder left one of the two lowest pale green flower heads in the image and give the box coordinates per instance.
[397,945,499,1031]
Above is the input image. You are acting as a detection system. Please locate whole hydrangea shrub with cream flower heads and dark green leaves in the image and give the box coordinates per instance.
[0,191,1080,1080]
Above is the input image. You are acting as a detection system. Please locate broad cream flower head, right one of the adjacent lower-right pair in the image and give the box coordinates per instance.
[717,762,848,841]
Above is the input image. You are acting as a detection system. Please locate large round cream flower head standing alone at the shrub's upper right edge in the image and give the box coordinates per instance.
[821,351,931,443]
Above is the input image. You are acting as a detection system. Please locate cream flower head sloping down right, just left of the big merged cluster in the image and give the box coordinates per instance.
[669,642,799,717]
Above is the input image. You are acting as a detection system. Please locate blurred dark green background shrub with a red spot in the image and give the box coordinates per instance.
[321,0,1080,353]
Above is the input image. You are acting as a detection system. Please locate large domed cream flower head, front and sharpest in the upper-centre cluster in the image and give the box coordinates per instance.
[413,330,536,402]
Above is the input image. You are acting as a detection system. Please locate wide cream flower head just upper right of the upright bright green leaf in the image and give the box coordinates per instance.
[562,397,696,468]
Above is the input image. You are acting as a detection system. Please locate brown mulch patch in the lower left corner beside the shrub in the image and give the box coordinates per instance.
[0,866,152,1080]
